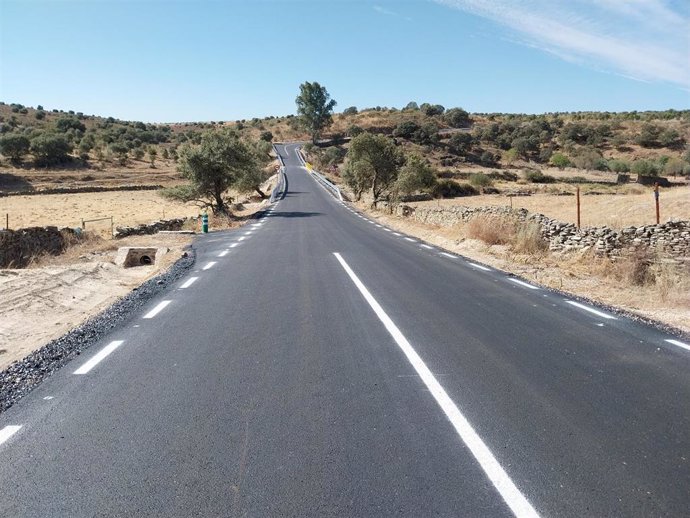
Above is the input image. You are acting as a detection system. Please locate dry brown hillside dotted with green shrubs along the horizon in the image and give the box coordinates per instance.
[0,103,690,196]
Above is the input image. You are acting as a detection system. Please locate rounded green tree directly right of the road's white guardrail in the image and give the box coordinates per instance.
[343,133,404,206]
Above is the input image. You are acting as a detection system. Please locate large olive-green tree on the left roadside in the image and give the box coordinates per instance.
[168,131,262,213]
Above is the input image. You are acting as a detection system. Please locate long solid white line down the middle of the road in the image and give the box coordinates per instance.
[333,252,539,518]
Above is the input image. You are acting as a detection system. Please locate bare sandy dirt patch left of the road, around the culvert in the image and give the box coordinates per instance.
[0,234,192,370]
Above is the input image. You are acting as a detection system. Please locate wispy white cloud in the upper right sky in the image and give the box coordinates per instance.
[434,0,690,89]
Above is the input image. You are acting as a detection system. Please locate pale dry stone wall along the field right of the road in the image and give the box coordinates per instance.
[395,205,690,259]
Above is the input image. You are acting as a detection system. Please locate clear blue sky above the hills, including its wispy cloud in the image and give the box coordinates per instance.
[0,0,690,122]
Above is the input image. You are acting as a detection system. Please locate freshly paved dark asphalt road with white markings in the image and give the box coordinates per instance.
[0,145,690,517]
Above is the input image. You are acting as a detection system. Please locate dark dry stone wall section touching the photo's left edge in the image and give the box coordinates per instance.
[0,227,80,268]
